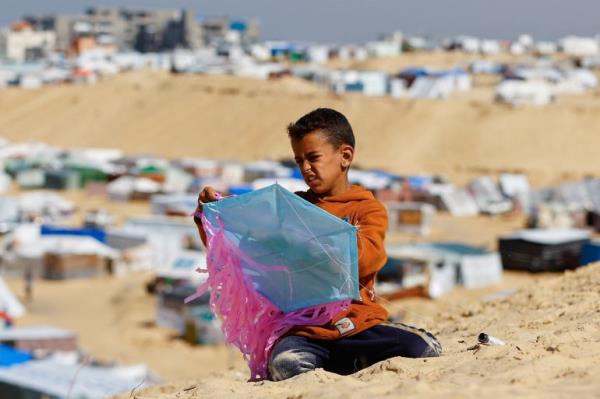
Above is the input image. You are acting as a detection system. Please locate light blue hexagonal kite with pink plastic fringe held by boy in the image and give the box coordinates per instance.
[186,184,359,379]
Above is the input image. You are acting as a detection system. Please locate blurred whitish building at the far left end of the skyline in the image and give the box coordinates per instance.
[0,21,56,62]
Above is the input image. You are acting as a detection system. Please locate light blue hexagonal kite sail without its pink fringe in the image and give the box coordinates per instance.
[203,184,359,313]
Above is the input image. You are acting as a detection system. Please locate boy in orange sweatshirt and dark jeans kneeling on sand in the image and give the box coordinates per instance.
[199,108,442,381]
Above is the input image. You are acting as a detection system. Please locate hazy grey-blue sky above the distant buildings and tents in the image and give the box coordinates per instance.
[0,0,600,42]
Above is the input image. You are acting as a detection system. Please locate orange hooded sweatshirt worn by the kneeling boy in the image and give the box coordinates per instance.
[196,186,388,340]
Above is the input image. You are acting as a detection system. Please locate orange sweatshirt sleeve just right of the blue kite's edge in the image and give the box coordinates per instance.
[357,202,388,278]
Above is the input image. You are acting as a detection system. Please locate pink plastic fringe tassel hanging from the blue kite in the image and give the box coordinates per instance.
[185,216,350,379]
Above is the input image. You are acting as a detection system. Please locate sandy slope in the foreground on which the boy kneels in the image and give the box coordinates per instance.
[122,264,600,399]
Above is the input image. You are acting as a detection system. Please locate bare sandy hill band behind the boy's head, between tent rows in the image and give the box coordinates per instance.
[0,73,600,183]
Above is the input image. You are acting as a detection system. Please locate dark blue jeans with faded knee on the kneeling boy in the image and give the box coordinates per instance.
[269,323,442,381]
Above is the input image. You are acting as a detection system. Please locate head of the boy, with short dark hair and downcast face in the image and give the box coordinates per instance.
[287,108,355,197]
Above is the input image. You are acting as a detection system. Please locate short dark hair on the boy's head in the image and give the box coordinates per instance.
[288,108,355,148]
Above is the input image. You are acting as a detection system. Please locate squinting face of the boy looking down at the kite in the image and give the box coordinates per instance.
[292,130,354,197]
